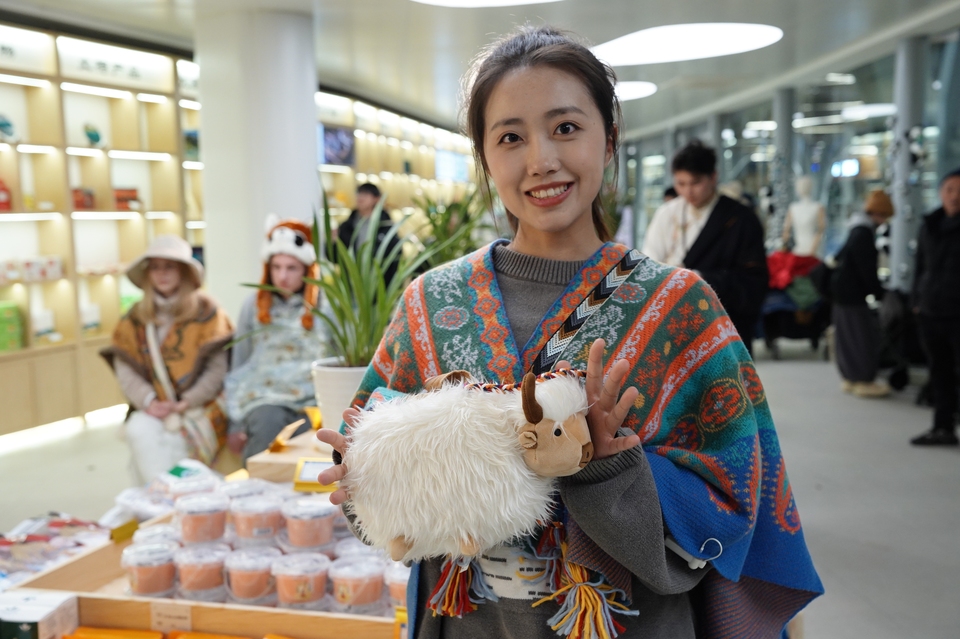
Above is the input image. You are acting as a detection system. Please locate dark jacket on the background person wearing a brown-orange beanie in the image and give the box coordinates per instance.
[831,219,884,306]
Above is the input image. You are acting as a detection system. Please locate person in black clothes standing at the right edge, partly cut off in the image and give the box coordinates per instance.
[910,169,960,446]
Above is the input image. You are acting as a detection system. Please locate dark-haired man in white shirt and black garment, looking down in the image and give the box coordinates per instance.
[643,140,768,352]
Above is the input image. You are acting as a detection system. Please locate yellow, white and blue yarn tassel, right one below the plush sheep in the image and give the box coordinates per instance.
[533,542,640,639]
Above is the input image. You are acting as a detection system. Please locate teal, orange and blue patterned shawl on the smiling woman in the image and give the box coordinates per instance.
[348,243,823,639]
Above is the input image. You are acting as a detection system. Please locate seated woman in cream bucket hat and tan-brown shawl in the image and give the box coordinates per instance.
[101,235,233,484]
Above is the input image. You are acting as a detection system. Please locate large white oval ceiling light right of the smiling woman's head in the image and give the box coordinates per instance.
[592,22,783,67]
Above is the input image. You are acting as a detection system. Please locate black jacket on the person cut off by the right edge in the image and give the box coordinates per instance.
[912,208,960,317]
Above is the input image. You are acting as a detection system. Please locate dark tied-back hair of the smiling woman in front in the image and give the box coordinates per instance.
[464,25,622,242]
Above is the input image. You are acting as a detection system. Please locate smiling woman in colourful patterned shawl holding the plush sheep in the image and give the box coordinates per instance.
[318,27,822,639]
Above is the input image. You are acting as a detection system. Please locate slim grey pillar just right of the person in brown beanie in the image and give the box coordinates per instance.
[890,37,925,292]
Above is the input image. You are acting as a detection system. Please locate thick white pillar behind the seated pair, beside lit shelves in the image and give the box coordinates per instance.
[195,0,319,318]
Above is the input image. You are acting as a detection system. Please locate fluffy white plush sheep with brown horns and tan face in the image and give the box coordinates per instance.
[341,370,593,561]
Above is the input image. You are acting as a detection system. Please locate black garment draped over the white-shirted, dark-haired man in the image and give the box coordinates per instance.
[683,195,769,346]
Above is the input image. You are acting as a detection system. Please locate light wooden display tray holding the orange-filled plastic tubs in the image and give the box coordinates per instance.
[20,528,394,639]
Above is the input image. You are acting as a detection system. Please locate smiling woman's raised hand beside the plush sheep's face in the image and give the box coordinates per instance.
[557,339,640,459]
